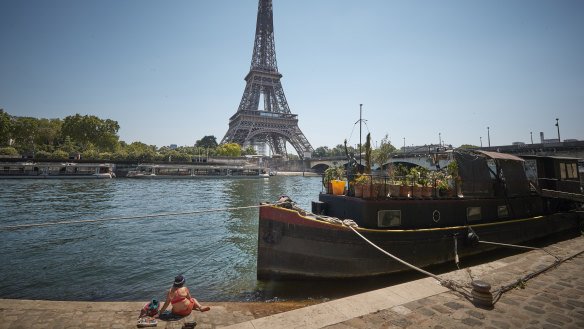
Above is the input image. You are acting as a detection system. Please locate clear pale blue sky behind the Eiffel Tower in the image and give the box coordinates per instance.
[0,0,584,153]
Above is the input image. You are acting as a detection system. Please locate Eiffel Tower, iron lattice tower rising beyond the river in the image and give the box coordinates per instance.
[221,0,314,159]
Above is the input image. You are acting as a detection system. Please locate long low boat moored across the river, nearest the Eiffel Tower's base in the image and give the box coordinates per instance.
[126,164,269,179]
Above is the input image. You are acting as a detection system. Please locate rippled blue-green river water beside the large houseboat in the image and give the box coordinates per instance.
[0,176,338,301]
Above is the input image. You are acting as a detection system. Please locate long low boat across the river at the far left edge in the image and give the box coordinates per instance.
[0,161,115,179]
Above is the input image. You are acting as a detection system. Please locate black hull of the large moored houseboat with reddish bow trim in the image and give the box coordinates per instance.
[257,206,582,280]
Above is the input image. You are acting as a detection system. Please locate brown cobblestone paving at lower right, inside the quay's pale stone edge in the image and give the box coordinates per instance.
[326,237,584,329]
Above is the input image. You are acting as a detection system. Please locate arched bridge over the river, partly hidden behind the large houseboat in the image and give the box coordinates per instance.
[269,141,584,173]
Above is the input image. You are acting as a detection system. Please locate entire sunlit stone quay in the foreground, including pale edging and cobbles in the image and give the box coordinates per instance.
[0,236,584,329]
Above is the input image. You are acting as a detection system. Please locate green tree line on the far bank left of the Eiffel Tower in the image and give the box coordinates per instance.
[0,109,256,162]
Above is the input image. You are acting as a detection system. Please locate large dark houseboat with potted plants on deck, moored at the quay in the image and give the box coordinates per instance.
[257,150,584,280]
